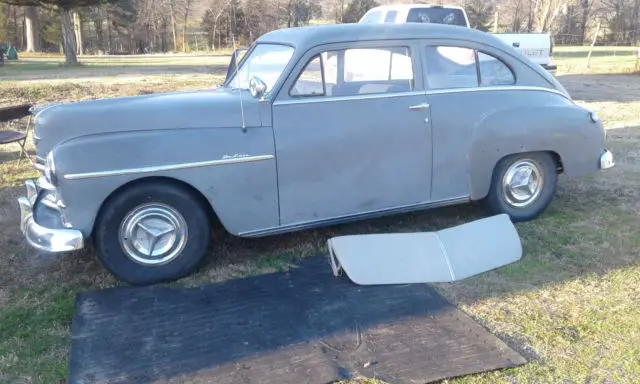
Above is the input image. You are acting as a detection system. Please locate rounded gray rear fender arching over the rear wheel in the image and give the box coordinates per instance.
[468,104,605,200]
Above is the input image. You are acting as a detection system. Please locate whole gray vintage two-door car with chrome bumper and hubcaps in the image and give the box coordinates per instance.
[19,24,614,285]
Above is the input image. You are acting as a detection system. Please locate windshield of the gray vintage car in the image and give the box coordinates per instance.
[228,44,293,93]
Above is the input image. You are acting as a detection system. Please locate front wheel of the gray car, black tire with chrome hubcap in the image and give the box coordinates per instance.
[94,182,211,285]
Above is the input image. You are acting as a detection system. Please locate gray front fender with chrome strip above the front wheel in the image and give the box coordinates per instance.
[54,127,278,236]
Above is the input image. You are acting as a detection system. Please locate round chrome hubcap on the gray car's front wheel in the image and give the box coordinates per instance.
[119,203,187,265]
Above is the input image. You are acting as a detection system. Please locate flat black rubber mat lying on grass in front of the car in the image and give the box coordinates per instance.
[68,257,525,384]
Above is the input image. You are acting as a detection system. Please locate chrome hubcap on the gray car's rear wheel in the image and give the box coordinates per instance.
[502,160,544,208]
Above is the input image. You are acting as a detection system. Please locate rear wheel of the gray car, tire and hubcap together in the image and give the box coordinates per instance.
[483,152,558,222]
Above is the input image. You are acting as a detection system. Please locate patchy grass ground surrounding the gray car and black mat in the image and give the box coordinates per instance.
[0,47,640,384]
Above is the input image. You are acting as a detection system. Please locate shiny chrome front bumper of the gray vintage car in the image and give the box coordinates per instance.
[18,180,84,253]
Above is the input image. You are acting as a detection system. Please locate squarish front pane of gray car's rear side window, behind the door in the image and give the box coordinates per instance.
[425,46,478,89]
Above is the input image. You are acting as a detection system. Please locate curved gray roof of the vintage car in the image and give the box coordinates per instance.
[256,23,508,50]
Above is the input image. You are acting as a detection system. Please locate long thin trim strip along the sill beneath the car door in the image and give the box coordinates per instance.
[238,196,471,237]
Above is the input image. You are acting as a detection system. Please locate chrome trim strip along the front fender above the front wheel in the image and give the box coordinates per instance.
[64,155,274,180]
